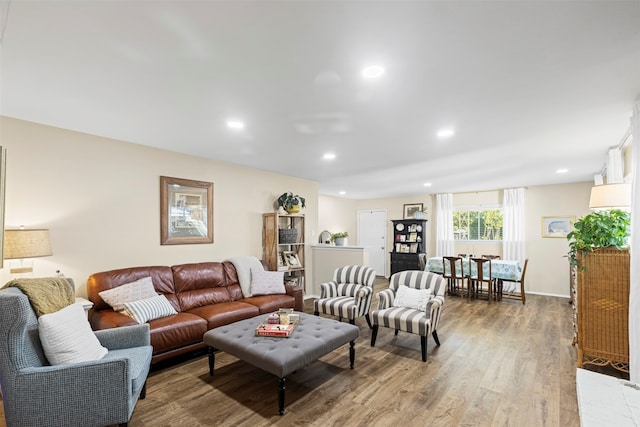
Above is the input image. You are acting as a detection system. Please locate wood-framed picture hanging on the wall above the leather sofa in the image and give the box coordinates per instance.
[160,176,213,245]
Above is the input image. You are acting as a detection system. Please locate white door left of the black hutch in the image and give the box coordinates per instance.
[358,210,387,277]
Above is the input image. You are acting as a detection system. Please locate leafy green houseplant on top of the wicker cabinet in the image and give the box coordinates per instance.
[567,209,630,268]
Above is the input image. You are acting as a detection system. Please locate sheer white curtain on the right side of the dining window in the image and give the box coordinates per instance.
[502,188,526,263]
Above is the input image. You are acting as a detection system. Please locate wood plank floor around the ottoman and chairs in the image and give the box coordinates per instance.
[3,279,620,427]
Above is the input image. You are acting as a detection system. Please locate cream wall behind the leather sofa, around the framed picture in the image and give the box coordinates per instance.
[0,117,318,295]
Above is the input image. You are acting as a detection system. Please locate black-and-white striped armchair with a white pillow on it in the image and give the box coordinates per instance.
[371,270,447,362]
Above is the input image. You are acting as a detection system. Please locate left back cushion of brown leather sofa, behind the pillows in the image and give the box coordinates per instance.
[87,266,180,311]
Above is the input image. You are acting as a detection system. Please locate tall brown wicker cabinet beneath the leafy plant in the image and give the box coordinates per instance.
[577,248,630,372]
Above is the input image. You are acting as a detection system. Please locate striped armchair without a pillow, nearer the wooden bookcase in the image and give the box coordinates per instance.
[313,265,376,328]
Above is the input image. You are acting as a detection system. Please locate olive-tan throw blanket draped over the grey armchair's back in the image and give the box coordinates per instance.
[6,277,76,317]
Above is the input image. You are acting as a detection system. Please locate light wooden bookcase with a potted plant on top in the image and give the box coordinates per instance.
[262,212,306,289]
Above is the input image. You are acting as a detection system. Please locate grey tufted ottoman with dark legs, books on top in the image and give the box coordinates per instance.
[203,313,359,415]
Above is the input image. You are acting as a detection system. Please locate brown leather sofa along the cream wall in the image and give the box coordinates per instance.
[87,262,303,363]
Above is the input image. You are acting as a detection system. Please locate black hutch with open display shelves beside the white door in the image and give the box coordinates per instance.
[391,219,427,274]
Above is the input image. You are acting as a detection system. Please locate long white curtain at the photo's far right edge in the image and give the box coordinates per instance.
[629,103,640,383]
